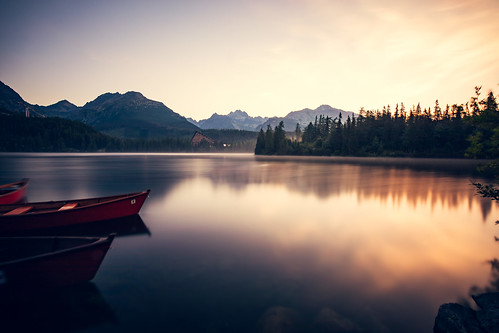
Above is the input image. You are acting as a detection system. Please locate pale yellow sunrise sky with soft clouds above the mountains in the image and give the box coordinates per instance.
[0,0,499,120]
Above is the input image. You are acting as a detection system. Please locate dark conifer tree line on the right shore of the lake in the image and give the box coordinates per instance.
[255,87,499,159]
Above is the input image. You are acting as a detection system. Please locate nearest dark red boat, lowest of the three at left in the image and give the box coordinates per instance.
[0,234,114,288]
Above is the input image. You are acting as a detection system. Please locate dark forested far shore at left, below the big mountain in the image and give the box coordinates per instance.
[0,110,258,152]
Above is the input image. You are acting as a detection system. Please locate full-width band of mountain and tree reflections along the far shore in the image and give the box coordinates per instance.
[2,154,492,219]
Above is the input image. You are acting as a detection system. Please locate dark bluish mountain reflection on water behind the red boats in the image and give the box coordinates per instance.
[0,154,191,202]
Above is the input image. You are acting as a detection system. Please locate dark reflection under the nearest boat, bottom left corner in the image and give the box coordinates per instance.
[0,282,118,332]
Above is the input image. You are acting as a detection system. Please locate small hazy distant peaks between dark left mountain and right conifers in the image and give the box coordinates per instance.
[188,110,268,131]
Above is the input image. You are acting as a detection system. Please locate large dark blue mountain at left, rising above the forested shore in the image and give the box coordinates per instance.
[0,81,199,139]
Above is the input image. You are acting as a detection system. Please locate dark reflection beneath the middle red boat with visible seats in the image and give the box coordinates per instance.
[2,214,151,237]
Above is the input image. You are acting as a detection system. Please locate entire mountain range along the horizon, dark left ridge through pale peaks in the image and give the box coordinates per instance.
[0,81,354,139]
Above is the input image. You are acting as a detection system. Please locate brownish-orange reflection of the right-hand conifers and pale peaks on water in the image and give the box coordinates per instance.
[197,158,492,220]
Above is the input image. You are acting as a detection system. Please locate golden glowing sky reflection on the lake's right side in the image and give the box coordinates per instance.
[148,156,499,304]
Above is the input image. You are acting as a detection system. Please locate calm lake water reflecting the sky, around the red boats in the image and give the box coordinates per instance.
[0,154,499,333]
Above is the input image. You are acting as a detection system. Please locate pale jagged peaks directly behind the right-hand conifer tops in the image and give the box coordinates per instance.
[258,105,355,132]
